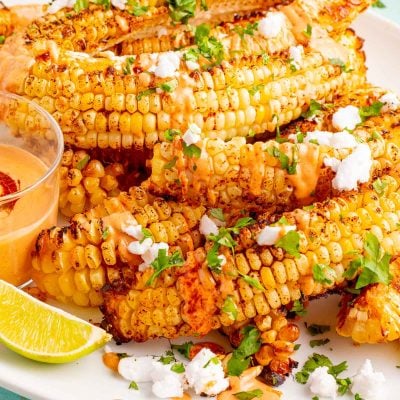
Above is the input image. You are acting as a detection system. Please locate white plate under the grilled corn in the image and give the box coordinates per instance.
[0,9,400,400]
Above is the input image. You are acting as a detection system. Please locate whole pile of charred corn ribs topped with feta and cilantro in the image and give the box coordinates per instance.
[0,0,400,388]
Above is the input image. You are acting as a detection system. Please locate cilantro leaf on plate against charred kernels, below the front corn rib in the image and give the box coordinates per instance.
[227,325,261,376]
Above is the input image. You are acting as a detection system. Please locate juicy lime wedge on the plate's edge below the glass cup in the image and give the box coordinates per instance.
[0,280,111,363]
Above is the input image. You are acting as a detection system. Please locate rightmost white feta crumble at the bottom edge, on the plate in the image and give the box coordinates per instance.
[351,359,386,400]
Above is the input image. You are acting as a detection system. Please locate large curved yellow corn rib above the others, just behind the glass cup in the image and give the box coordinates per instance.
[0,6,365,150]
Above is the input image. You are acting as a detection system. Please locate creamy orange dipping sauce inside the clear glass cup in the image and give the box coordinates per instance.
[0,144,58,285]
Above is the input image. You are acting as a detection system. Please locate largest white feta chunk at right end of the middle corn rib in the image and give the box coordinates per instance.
[332,143,372,190]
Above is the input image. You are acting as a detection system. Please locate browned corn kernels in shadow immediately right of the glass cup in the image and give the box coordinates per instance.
[59,150,124,217]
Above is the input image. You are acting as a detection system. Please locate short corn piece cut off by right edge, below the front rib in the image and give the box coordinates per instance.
[336,258,400,343]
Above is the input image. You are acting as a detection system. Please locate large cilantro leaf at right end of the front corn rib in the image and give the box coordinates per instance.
[343,232,392,289]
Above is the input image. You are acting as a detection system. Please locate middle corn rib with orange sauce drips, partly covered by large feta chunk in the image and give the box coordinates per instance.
[149,105,400,209]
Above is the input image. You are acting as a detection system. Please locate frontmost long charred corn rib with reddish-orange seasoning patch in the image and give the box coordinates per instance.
[102,175,400,341]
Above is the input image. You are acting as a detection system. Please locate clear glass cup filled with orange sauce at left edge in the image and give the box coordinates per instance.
[0,91,63,286]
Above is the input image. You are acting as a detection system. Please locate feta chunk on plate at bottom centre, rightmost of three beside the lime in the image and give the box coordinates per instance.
[186,348,229,396]
